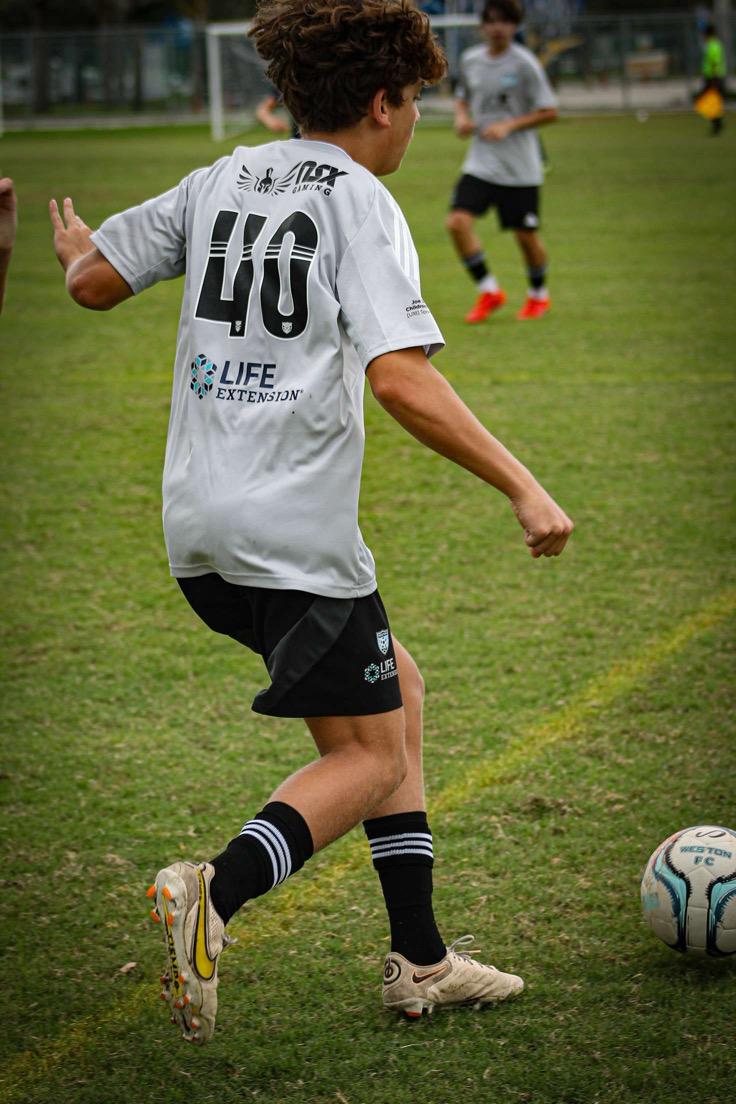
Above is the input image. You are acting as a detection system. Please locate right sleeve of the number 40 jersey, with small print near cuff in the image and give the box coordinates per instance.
[335,185,445,369]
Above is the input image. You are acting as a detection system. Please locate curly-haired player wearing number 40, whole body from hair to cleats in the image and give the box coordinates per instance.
[51,0,572,1042]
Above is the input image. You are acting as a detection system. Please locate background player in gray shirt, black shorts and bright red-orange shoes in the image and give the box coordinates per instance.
[447,0,557,322]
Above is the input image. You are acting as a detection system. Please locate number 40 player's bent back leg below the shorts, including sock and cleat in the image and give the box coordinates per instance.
[149,709,406,1044]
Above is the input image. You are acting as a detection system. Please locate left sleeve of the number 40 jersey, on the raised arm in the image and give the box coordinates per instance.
[92,168,210,295]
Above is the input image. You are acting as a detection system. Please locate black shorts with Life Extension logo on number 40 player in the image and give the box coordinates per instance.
[177,573,402,716]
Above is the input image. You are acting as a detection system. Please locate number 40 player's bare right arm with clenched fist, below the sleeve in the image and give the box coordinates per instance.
[367,349,573,559]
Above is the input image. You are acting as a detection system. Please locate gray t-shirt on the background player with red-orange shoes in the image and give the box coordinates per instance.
[455,42,557,188]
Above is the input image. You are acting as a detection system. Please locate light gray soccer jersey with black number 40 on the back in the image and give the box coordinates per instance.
[93,140,444,597]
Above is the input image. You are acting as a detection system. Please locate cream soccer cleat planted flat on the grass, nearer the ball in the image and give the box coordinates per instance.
[383,935,524,1019]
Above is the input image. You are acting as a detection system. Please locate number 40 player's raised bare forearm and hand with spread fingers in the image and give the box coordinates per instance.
[49,198,132,310]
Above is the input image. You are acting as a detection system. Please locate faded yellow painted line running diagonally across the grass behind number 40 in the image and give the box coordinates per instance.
[0,590,736,1104]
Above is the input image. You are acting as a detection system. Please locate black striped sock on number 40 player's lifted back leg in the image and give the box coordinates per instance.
[210,802,314,924]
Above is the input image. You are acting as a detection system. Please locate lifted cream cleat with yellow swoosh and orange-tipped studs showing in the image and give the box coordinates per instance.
[148,862,233,1045]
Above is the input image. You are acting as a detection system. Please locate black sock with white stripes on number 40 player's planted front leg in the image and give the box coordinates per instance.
[363,813,446,966]
